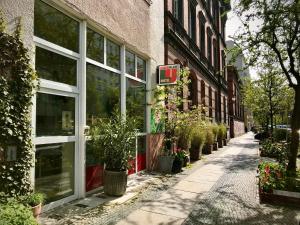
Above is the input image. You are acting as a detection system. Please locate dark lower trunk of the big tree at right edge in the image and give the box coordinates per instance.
[287,85,300,174]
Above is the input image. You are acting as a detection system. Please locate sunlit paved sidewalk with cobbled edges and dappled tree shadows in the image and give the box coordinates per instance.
[40,133,300,225]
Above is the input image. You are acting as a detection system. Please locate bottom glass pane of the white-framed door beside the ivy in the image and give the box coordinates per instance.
[35,142,75,202]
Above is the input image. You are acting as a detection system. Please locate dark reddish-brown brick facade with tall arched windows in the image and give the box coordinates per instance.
[165,0,230,124]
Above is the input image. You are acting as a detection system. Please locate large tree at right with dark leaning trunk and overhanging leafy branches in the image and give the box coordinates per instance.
[234,0,300,173]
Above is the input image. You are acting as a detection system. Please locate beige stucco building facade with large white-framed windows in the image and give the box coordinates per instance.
[0,0,164,210]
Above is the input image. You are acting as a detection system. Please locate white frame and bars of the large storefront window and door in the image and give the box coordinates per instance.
[31,0,151,211]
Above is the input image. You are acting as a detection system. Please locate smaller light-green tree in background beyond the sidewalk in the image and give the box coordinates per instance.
[242,63,293,133]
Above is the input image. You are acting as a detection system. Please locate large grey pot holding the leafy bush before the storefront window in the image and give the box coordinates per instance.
[104,170,127,196]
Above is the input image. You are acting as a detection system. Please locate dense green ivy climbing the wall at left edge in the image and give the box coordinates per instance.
[0,15,37,196]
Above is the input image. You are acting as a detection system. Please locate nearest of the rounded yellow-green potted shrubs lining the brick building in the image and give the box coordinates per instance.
[190,121,206,160]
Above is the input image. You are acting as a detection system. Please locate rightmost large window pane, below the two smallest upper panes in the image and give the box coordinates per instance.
[126,78,146,132]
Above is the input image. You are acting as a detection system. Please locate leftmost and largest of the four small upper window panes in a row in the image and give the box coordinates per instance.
[86,28,104,63]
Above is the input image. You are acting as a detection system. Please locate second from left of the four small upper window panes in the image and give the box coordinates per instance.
[106,39,120,70]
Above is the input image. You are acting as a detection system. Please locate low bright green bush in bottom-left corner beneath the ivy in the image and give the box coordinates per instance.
[0,201,38,225]
